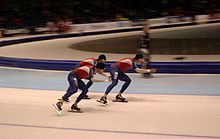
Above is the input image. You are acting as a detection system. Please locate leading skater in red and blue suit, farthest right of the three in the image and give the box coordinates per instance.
[99,54,156,104]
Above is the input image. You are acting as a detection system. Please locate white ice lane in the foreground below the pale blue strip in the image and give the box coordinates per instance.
[0,88,220,139]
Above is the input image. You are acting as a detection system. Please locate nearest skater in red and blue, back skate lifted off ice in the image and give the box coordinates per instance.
[54,62,107,111]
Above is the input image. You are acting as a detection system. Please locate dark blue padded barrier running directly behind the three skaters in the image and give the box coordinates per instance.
[0,57,220,74]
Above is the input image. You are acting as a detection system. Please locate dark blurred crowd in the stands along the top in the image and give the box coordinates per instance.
[0,0,220,28]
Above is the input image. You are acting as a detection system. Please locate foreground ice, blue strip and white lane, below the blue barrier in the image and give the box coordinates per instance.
[0,67,220,139]
